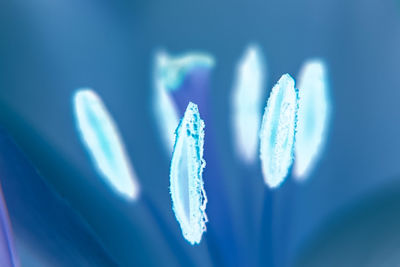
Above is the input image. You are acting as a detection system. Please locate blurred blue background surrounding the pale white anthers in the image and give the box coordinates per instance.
[0,0,400,266]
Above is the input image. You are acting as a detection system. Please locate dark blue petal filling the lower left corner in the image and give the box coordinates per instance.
[0,129,116,266]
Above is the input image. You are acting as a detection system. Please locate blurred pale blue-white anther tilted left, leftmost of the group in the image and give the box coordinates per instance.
[73,89,139,199]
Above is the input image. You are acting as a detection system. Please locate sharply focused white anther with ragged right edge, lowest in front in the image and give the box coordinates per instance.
[170,103,207,245]
